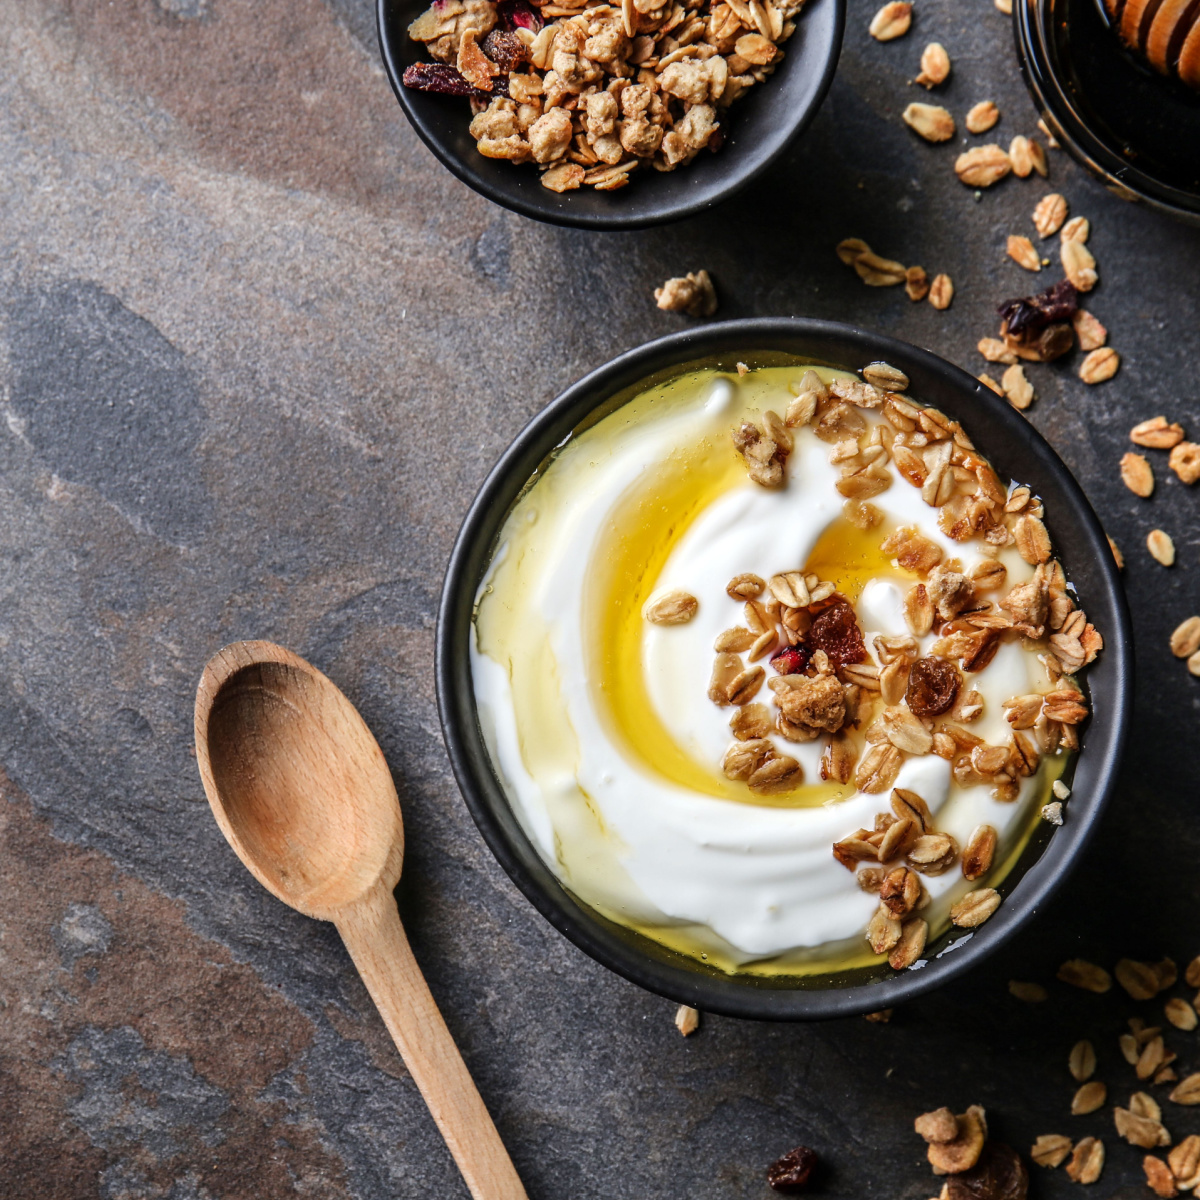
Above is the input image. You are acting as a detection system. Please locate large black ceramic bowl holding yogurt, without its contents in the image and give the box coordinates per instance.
[437,318,1133,1019]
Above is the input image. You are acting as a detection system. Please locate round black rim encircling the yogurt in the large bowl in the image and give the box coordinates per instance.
[436,317,1133,1020]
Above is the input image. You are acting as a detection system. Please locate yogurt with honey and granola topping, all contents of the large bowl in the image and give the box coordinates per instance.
[470,350,1103,977]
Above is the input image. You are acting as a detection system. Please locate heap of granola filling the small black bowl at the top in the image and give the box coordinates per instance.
[404,0,804,192]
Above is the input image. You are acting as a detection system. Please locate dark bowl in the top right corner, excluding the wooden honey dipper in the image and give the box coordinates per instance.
[1013,0,1200,223]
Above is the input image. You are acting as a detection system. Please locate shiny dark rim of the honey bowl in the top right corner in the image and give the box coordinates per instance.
[1013,0,1200,224]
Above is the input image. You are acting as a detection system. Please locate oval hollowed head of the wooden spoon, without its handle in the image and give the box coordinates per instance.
[197,642,404,920]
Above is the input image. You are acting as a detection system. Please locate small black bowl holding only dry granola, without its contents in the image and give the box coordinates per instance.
[377,0,846,229]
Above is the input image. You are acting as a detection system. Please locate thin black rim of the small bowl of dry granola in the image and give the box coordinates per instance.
[376,0,847,230]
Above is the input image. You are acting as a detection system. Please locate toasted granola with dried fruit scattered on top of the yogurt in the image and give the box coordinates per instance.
[708,364,1103,970]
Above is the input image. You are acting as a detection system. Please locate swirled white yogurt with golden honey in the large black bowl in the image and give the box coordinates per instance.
[470,366,1091,973]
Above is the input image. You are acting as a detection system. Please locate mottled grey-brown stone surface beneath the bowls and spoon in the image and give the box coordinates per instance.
[0,0,1200,1200]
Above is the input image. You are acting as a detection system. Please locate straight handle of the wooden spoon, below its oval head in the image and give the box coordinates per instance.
[336,888,528,1200]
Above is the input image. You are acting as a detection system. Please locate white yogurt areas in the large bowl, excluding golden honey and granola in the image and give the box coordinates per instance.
[472,368,1048,970]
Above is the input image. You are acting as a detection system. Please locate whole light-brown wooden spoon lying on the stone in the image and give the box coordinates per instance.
[196,642,527,1200]
